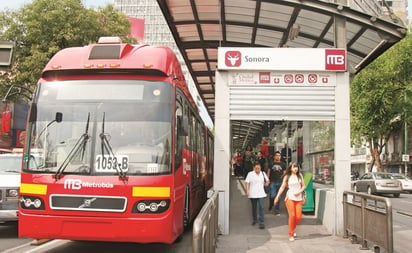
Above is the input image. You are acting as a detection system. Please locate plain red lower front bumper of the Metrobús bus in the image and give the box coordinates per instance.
[19,212,179,243]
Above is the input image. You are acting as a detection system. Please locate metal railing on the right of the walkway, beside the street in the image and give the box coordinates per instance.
[343,191,393,253]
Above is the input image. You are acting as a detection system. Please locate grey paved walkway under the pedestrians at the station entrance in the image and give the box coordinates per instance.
[216,176,373,253]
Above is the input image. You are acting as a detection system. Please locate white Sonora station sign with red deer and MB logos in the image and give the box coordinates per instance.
[218,47,347,72]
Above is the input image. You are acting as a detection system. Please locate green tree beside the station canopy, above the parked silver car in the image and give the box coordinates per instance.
[351,34,412,171]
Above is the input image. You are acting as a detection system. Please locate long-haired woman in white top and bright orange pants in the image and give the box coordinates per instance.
[274,162,306,241]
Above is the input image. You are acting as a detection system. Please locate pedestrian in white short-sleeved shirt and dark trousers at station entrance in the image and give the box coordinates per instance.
[245,162,269,229]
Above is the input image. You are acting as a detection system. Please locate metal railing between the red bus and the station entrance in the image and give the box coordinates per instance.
[192,191,219,253]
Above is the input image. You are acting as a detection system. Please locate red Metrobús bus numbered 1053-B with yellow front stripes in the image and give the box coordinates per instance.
[19,36,213,243]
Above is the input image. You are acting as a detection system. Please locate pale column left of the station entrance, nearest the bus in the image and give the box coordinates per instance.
[213,71,231,235]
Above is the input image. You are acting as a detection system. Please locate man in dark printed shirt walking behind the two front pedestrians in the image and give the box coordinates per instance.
[267,151,286,215]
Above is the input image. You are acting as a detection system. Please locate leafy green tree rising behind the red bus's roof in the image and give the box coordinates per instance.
[0,0,135,101]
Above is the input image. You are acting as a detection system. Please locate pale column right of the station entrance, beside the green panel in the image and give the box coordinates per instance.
[332,72,351,235]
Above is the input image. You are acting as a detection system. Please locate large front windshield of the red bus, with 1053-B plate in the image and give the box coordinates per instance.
[24,80,172,176]
